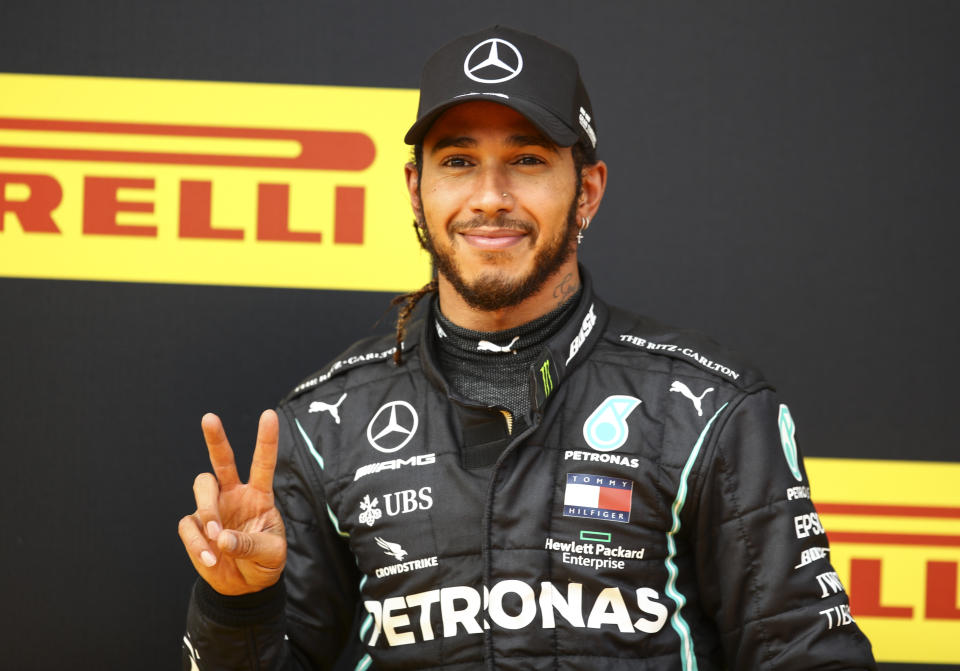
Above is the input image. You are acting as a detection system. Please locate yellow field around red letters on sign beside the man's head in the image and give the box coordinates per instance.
[0,74,429,291]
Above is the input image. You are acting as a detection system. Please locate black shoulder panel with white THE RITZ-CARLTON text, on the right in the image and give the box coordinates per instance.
[603,306,771,393]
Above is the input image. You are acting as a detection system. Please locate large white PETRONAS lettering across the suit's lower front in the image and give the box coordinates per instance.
[363,580,669,646]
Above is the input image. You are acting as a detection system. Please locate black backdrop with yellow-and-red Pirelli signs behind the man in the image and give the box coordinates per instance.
[0,0,960,670]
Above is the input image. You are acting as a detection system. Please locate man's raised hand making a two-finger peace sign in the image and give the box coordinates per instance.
[179,410,287,595]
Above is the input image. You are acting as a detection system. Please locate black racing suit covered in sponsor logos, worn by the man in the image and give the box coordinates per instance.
[184,278,875,671]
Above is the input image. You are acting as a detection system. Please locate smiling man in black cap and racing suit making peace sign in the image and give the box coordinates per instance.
[180,27,875,671]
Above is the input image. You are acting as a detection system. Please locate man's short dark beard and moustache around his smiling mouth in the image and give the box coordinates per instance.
[417,193,580,312]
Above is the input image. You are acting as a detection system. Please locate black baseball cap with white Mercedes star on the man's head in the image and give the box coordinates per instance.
[404,26,597,148]
